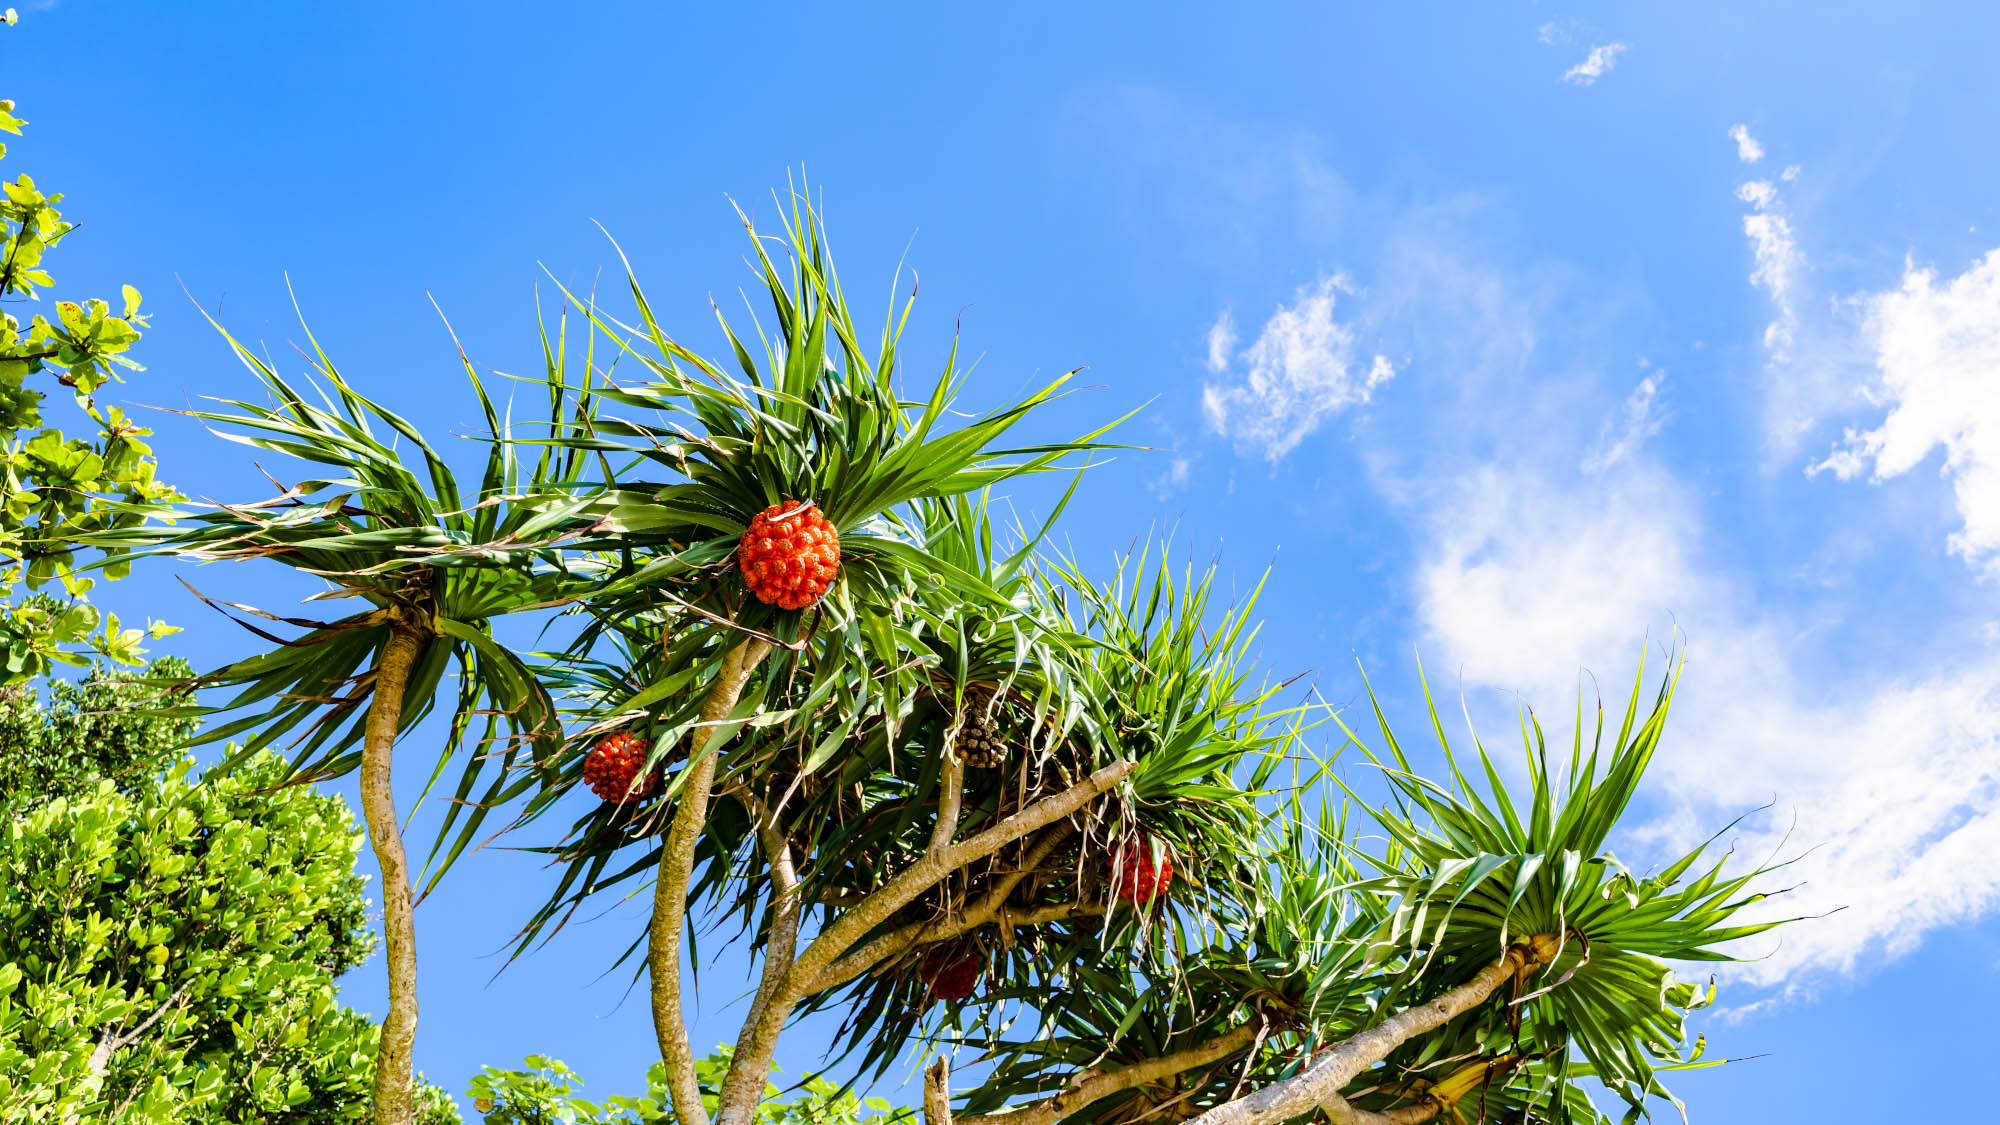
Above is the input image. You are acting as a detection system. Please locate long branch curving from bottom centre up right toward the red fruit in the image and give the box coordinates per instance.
[712,759,1138,1125]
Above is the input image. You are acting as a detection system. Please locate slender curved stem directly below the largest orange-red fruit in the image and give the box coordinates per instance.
[646,637,770,1125]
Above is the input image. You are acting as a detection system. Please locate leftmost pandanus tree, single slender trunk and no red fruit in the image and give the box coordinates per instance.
[100,308,590,1123]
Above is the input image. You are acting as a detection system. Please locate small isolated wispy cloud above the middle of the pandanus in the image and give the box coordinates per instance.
[1202,274,1396,462]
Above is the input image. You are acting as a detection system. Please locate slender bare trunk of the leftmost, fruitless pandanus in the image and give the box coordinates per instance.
[362,619,428,1125]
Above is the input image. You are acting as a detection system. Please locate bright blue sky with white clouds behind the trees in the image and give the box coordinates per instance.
[0,0,2000,1125]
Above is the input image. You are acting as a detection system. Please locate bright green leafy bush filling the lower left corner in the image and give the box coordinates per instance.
[0,740,456,1125]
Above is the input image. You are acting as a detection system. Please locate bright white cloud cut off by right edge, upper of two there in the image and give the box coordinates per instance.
[1808,248,2000,577]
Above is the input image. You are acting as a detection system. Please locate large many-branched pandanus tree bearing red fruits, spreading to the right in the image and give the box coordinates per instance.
[504,201,1800,1125]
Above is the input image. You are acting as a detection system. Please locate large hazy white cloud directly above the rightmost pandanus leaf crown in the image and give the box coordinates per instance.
[1416,464,2000,987]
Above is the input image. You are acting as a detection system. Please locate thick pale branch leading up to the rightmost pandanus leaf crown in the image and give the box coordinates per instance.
[1168,933,1562,1125]
